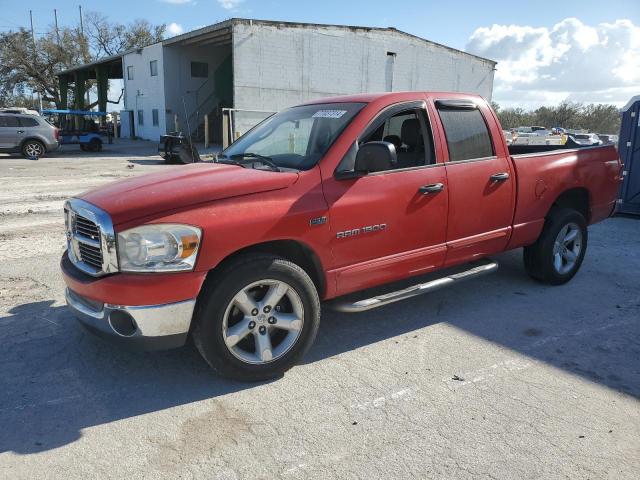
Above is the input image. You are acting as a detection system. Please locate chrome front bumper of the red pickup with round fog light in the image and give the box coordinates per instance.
[65,288,196,350]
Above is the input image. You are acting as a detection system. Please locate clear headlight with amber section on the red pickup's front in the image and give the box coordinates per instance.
[118,224,202,272]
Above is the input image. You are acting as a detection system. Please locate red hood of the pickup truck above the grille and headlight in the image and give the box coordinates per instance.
[79,163,298,225]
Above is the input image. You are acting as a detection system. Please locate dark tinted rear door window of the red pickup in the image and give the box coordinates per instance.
[438,109,493,162]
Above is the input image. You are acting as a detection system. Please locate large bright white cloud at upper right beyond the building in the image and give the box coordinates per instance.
[466,18,640,107]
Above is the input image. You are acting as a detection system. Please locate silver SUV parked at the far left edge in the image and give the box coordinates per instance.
[0,112,60,158]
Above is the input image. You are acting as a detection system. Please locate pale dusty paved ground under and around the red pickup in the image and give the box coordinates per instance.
[0,142,640,479]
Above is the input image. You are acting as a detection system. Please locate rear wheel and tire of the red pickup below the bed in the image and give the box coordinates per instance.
[523,208,588,285]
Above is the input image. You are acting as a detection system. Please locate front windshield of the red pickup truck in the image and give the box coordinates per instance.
[218,103,365,170]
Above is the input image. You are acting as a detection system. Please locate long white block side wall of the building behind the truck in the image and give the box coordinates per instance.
[233,22,494,111]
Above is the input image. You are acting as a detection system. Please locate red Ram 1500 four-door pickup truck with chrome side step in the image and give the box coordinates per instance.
[61,92,621,380]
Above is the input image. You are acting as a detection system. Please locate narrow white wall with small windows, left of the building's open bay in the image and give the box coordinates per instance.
[122,43,167,141]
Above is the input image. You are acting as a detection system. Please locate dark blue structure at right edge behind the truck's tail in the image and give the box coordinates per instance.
[618,95,640,215]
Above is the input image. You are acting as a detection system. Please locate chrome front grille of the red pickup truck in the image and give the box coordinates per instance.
[64,198,118,277]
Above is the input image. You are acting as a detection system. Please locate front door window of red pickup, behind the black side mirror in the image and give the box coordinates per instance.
[360,109,435,169]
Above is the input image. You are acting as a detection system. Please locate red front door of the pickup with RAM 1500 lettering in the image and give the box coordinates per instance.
[323,102,448,295]
